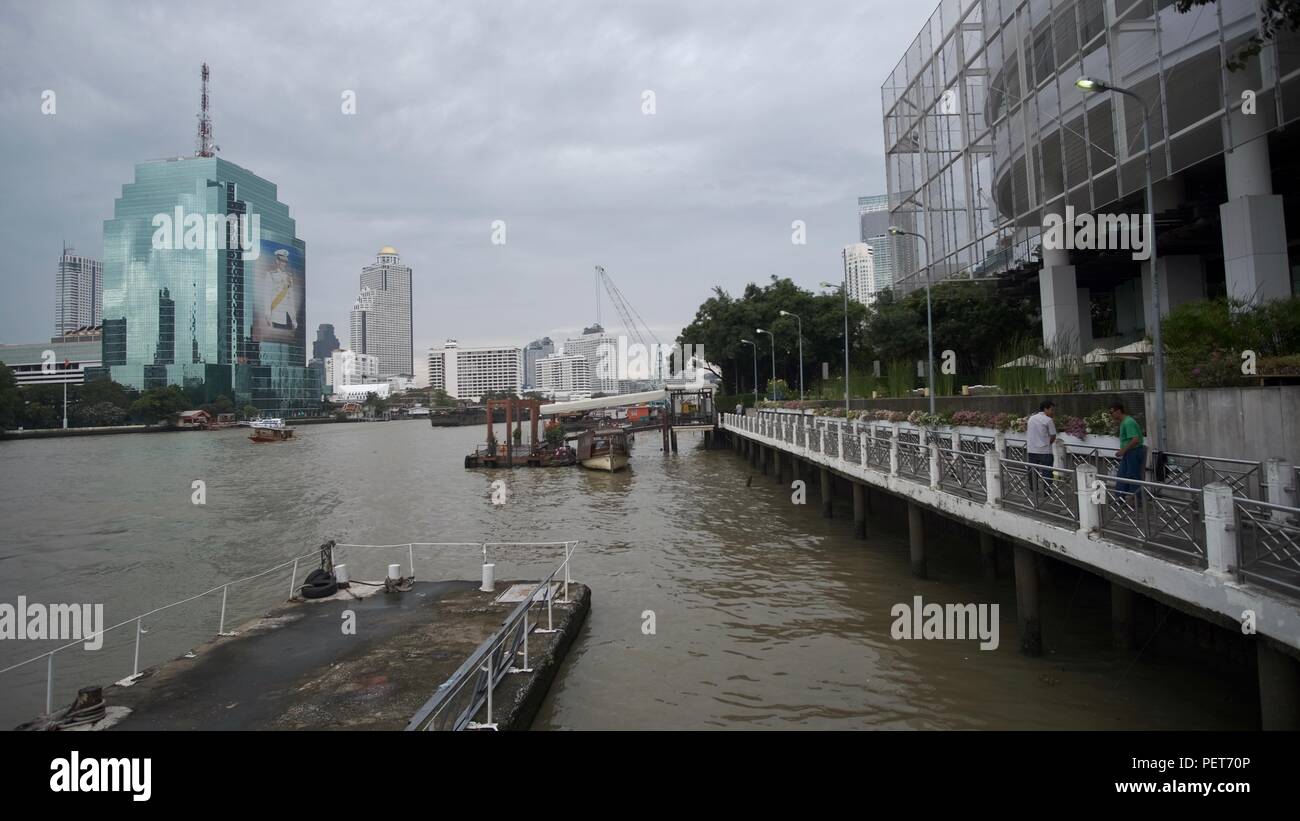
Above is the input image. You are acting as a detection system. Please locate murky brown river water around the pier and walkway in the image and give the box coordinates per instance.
[0,421,1256,729]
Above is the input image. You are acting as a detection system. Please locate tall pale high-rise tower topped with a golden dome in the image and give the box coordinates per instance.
[352,246,415,377]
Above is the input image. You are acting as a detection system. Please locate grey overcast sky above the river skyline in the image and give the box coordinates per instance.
[0,0,933,360]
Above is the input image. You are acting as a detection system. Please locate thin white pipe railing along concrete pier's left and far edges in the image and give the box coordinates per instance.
[0,542,577,714]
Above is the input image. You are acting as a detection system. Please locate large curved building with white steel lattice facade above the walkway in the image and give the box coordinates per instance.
[881,0,1300,351]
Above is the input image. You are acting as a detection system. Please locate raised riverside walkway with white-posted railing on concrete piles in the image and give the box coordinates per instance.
[719,411,1300,729]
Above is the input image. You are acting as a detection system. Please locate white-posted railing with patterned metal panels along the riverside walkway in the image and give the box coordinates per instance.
[723,417,1300,595]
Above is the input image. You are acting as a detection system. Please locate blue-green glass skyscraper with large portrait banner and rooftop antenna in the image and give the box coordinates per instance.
[103,157,321,416]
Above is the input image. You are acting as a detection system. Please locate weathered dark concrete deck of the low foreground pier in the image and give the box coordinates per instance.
[96,581,586,730]
